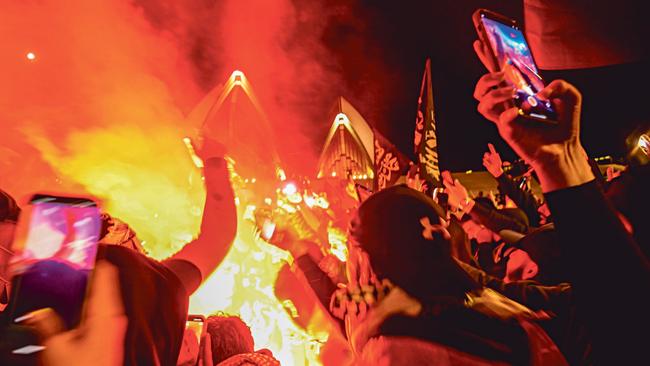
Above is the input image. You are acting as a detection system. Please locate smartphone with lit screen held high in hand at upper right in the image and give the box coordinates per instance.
[472,9,557,124]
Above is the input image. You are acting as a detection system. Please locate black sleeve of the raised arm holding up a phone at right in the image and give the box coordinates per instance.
[546,181,650,365]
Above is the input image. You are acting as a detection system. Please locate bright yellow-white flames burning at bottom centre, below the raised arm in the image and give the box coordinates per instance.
[190,209,328,365]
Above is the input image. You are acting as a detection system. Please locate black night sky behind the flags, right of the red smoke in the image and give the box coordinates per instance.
[324,0,650,171]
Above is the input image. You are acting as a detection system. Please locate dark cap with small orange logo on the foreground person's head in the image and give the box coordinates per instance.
[350,185,478,303]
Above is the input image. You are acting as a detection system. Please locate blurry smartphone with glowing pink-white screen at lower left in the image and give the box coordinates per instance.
[8,194,101,329]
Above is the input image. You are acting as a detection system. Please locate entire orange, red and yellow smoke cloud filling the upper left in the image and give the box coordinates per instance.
[0,0,360,257]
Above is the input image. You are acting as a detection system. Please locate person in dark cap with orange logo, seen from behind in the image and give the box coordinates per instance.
[331,186,566,365]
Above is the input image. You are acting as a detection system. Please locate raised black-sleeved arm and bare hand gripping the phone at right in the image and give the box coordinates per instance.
[475,40,650,364]
